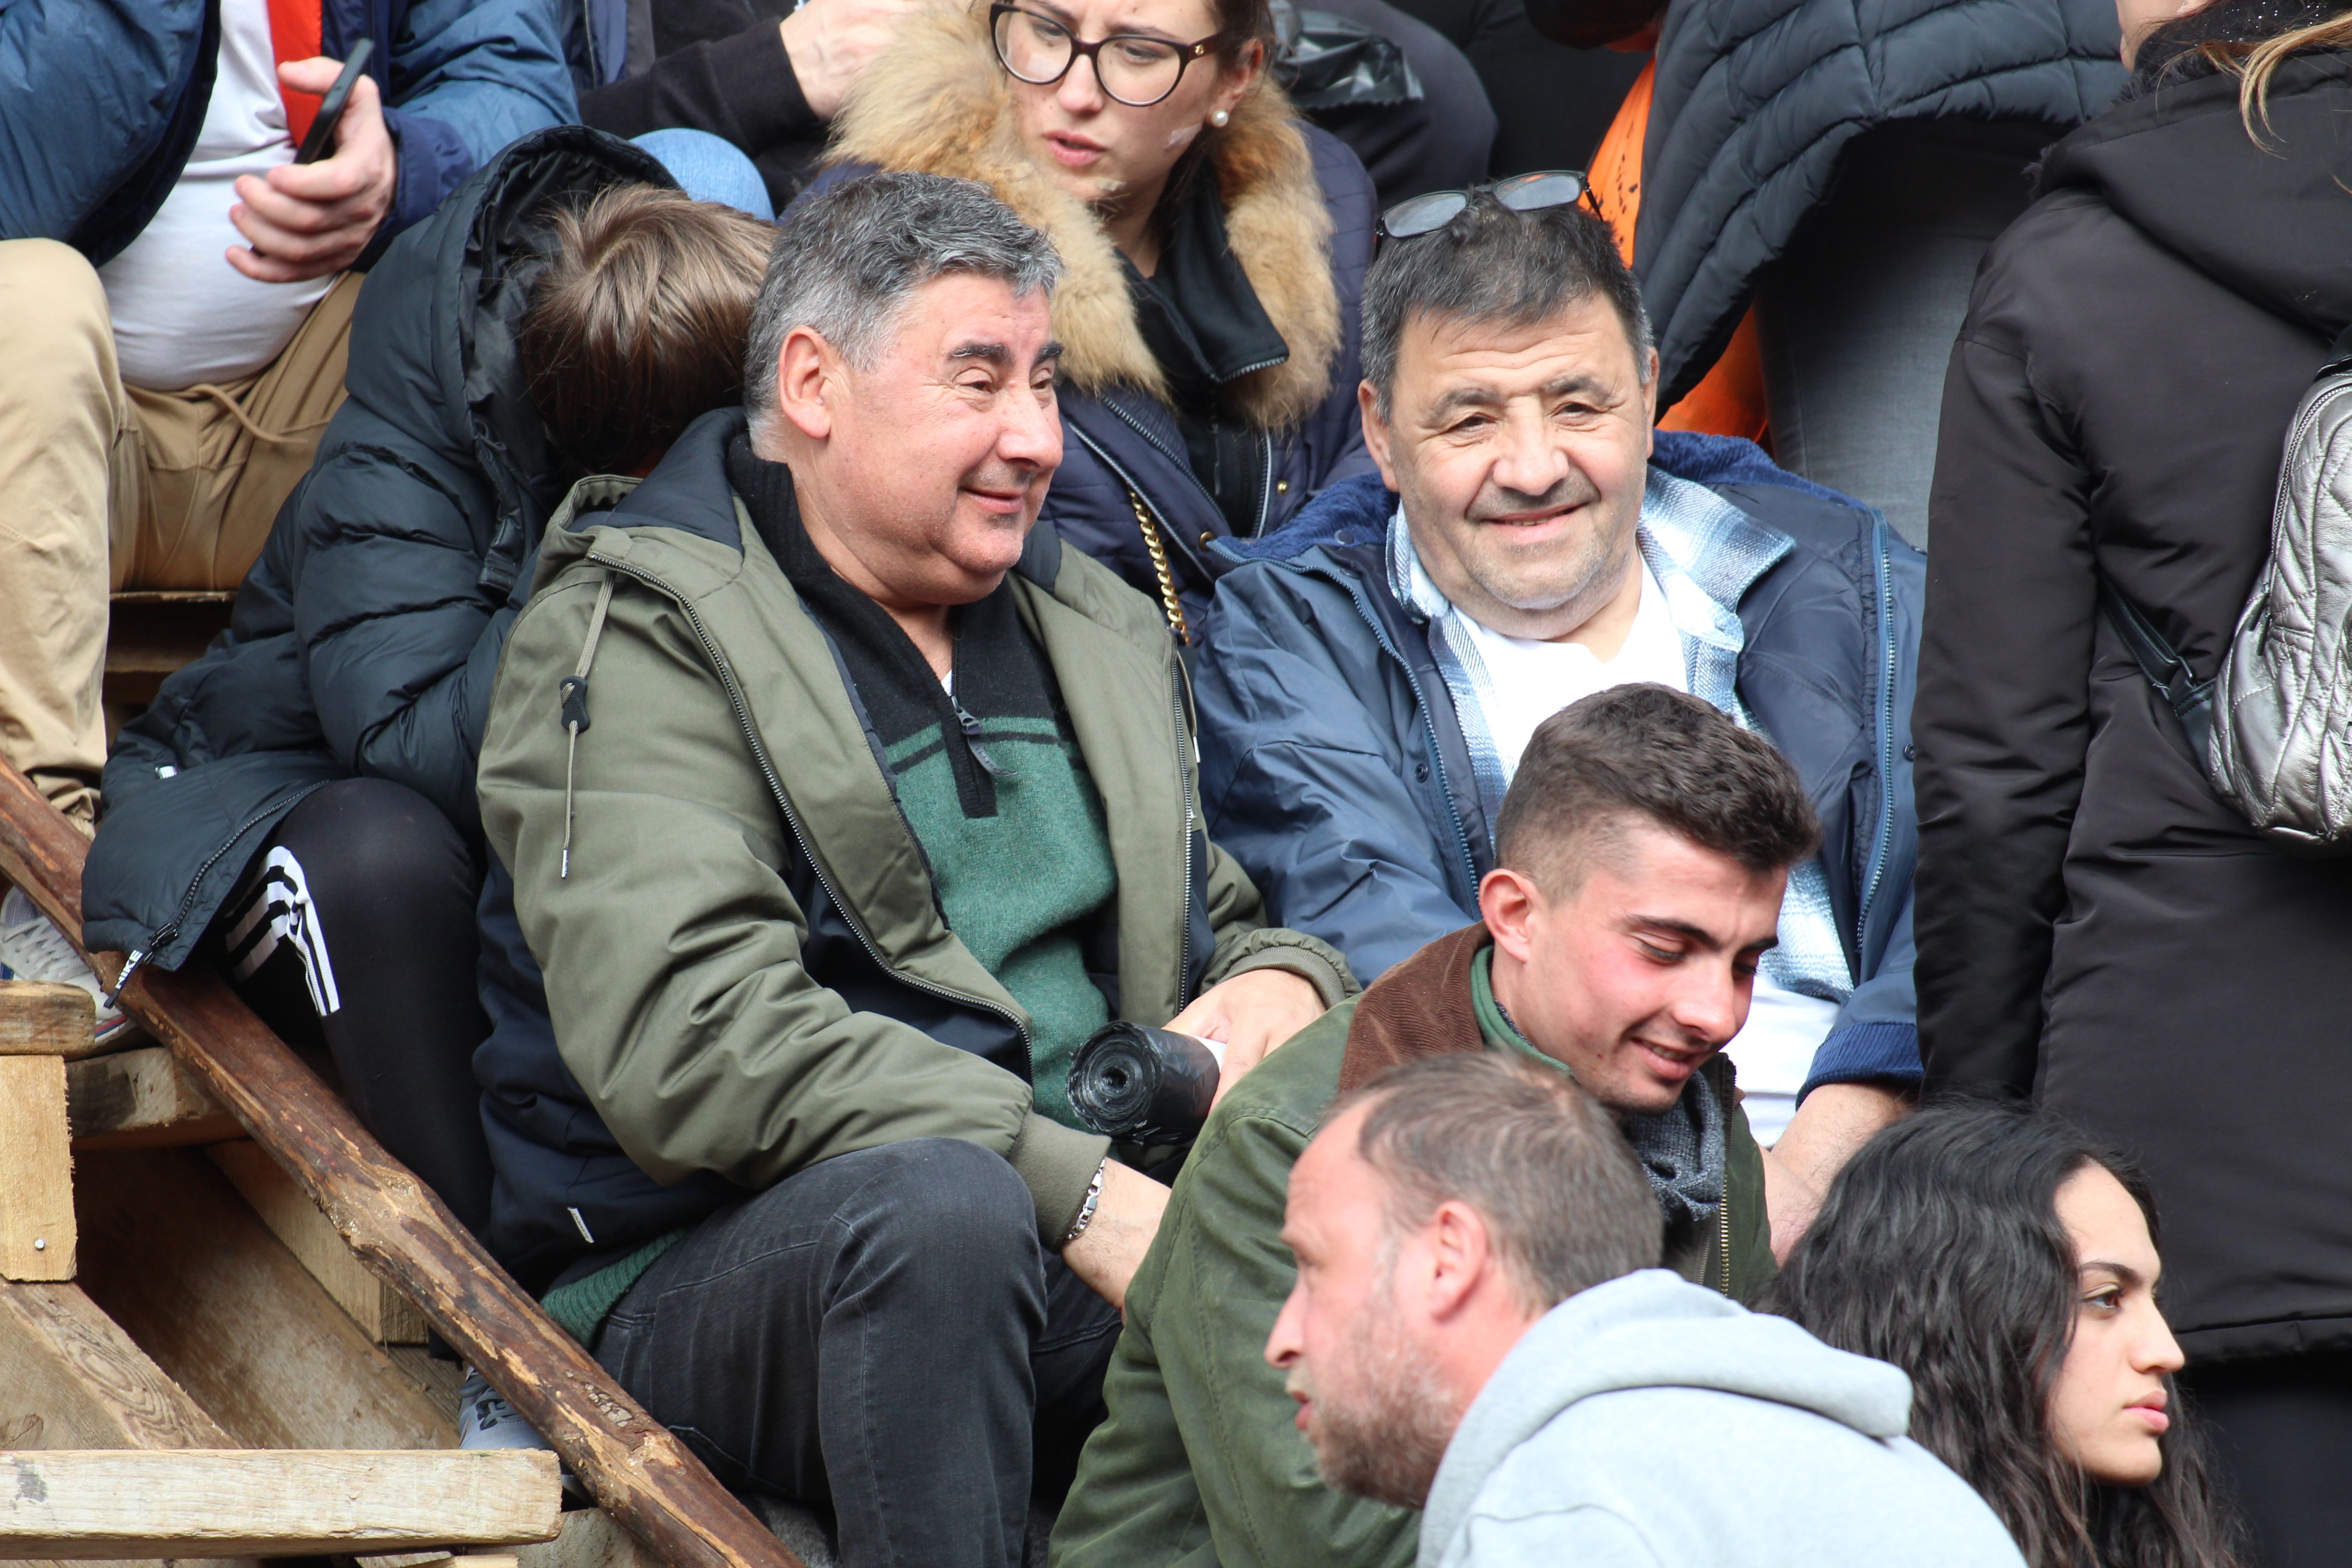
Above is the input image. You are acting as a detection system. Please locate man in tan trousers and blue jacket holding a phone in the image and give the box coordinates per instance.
[0,0,576,1029]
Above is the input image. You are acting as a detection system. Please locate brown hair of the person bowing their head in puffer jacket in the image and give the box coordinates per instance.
[515,186,776,472]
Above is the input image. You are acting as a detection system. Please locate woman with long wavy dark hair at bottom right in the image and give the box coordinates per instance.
[1764,1105,2241,1568]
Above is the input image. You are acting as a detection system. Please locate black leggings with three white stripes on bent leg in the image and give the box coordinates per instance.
[207,778,489,1230]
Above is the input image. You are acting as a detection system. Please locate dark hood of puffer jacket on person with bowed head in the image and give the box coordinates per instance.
[343,125,677,588]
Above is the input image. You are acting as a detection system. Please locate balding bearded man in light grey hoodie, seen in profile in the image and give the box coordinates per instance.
[1265,1053,2023,1568]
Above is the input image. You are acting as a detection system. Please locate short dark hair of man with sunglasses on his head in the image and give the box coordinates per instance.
[1364,191,1653,418]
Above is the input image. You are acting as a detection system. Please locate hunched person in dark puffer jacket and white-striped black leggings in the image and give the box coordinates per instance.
[82,127,769,1227]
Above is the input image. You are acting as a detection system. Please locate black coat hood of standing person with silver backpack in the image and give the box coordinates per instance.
[2039,54,2352,336]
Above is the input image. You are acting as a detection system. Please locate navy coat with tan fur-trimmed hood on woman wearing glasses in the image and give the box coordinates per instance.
[783,7,1378,635]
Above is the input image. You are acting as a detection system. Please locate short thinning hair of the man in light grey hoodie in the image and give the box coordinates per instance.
[1324,1051,1665,1312]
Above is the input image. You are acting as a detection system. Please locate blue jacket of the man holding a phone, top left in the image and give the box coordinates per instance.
[0,0,581,265]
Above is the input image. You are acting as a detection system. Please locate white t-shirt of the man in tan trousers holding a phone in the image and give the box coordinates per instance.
[99,0,334,392]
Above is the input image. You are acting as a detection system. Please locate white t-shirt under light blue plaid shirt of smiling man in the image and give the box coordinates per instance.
[1463,557,1837,1147]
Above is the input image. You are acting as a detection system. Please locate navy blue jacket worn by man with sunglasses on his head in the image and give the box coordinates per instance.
[1195,430,1924,1088]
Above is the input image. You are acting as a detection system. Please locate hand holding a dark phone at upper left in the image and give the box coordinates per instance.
[228,56,400,282]
